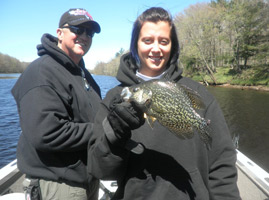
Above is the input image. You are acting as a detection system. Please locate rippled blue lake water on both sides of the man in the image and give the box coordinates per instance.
[0,74,119,168]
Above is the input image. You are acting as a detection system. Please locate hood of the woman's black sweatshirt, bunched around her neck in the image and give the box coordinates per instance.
[116,53,182,86]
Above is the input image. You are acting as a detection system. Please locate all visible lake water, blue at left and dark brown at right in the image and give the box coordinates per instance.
[0,74,269,172]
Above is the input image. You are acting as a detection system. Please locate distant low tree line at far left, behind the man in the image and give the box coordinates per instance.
[0,53,29,73]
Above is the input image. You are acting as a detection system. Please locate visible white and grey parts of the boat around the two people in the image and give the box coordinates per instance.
[0,150,269,200]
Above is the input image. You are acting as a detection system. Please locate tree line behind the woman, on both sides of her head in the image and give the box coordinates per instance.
[92,0,269,85]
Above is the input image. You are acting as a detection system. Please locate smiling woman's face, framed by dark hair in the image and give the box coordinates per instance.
[137,21,172,76]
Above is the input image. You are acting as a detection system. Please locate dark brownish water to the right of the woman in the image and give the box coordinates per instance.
[208,87,269,171]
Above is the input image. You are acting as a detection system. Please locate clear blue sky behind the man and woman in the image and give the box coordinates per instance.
[0,0,210,69]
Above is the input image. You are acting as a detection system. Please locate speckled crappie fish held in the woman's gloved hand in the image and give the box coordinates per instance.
[121,80,212,148]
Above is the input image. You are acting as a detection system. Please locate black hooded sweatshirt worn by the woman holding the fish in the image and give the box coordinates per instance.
[88,54,240,200]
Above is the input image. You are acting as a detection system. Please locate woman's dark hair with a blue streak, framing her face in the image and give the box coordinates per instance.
[130,7,179,65]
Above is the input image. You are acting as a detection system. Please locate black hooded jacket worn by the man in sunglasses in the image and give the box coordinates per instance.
[12,34,101,187]
